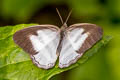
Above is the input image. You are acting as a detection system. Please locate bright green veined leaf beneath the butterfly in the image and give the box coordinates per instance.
[0,24,112,80]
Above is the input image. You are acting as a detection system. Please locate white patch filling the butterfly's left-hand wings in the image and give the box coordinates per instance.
[30,29,60,69]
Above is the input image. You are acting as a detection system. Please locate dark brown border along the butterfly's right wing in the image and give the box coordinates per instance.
[67,23,103,54]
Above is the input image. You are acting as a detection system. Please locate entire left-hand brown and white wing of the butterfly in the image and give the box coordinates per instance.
[13,25,60,69]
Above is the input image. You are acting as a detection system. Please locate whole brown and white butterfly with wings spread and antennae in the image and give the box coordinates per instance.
[13,9,103,69]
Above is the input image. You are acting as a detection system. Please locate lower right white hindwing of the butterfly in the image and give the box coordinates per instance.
[59,35,81,68]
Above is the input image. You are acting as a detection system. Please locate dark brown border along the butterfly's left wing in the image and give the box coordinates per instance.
[13,25,60,55]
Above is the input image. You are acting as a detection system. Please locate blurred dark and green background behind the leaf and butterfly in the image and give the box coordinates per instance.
[0,0,120,80]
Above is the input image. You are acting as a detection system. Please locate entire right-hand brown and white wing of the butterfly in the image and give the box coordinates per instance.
[59,23,103,68]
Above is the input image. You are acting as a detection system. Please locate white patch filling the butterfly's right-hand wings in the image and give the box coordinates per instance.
[59,28,89,68]
